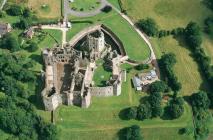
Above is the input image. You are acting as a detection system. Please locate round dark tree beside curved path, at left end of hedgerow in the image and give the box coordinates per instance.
[138,18,158,36]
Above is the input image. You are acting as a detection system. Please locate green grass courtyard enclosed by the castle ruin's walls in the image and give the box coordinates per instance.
[93,60,112,87]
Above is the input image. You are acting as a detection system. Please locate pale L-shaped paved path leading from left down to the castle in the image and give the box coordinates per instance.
[41,25,68,45]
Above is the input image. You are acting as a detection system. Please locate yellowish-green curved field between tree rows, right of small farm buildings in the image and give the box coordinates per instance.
[151,36,208,96]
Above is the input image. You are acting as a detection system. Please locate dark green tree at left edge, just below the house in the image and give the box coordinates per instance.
[0,33,20,52]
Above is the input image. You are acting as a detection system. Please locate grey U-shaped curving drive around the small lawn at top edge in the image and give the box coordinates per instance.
[64,0,109,19]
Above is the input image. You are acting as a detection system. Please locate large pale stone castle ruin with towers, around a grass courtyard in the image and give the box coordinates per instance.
[41,30,128,111]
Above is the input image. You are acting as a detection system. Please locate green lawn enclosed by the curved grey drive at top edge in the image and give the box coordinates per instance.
[70,0,101,12]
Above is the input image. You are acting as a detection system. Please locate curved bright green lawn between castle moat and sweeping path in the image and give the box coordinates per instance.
[68,11,150,61]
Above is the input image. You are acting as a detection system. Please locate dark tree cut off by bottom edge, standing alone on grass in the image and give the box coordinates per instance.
[124,125,143,140]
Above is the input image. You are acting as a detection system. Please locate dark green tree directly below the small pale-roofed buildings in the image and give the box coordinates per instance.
[150,81,168,93]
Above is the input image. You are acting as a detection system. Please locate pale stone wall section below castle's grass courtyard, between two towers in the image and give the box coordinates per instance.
[90,86,113,97]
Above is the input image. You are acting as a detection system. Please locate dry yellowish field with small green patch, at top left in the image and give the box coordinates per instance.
[27,0,61,19]
